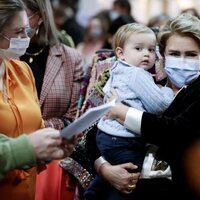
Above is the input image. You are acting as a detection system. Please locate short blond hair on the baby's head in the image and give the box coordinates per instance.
[112,23,154,49]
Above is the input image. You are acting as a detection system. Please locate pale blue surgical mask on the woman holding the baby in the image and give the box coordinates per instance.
[164,56,200,88]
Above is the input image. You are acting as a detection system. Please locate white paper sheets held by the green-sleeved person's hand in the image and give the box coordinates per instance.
[60,100,115,139]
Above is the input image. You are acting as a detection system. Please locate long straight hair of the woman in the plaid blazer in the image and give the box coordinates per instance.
[22,0,62,46]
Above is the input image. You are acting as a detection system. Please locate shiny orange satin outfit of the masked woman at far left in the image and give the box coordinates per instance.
[0,60,44,200]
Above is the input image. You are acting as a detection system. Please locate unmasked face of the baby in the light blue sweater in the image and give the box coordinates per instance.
[122,33,156,70]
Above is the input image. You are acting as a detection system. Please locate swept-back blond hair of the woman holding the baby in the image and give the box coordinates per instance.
[157,14,200,55]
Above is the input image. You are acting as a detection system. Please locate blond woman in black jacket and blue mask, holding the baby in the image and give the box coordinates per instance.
[96,14,200,200]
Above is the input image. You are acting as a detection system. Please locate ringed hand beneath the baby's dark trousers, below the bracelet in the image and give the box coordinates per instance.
[99,163,140,194]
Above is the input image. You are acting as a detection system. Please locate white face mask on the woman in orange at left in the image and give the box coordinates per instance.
[0,36,30,60]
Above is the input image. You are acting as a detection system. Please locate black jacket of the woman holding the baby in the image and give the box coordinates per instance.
[141,77,200,200]
